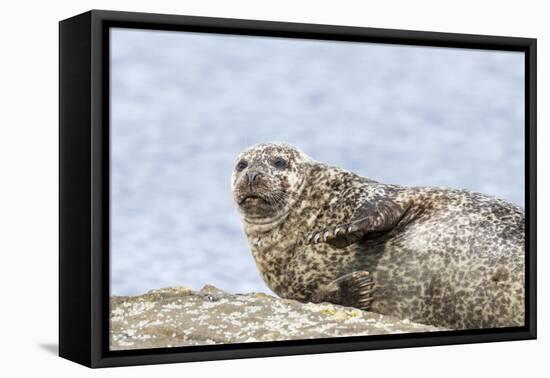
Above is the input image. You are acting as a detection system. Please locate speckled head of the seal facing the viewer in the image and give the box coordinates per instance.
[231,143,310,225]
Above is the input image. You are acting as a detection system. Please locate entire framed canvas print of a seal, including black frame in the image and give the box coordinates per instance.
[59,10,536,367]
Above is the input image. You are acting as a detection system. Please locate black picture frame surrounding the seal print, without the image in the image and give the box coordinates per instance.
[59,10,537,368]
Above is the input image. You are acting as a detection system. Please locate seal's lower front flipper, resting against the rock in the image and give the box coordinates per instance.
[313,270,374,311]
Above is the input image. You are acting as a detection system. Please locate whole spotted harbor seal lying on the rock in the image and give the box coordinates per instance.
[232,143,525,329]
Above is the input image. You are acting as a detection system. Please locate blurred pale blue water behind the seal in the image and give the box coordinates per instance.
[111,29,524,295]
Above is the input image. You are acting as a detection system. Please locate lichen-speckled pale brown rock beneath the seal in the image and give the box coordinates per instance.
[110,285,443,350]
